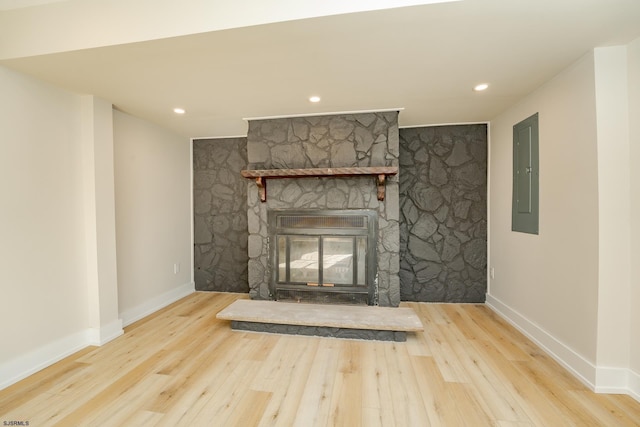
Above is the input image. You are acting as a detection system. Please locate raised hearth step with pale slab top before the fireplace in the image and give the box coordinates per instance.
[216,300,423,341]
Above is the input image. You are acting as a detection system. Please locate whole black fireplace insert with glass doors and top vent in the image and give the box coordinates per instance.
[268,209,378,305]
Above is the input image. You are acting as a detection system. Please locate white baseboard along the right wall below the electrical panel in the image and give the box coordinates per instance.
[486,294,640,401]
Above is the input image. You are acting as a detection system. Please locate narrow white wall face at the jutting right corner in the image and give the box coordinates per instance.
[594,46,631,384]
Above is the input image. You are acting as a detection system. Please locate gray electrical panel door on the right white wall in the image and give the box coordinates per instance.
[511,113,540,234]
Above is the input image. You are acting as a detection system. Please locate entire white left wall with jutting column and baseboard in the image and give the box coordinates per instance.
[0,67,194,389]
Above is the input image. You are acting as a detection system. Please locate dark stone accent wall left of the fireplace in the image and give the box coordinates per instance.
[193,138,249,293]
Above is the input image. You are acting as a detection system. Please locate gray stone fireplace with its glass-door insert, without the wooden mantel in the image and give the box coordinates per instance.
[247,111,400,306]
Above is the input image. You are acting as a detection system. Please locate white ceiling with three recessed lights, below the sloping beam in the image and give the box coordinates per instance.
[0,0,640,137]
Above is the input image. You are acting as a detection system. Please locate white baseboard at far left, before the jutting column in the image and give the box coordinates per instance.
[0,330,90,390]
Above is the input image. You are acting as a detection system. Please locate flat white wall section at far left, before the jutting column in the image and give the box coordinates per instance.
[0,67,89,388]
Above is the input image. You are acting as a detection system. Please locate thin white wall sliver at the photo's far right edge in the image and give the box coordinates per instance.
[627,38,640,392]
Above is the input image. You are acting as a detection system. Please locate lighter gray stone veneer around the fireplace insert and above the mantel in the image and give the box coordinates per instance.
[246,112,400,306]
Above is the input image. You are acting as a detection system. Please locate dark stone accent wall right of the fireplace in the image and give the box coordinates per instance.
[400,125,487,302]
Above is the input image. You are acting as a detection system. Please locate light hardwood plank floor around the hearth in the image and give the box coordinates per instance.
[0,292,640,427]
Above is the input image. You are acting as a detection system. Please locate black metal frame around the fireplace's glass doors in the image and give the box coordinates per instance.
[267,209,378,305]
